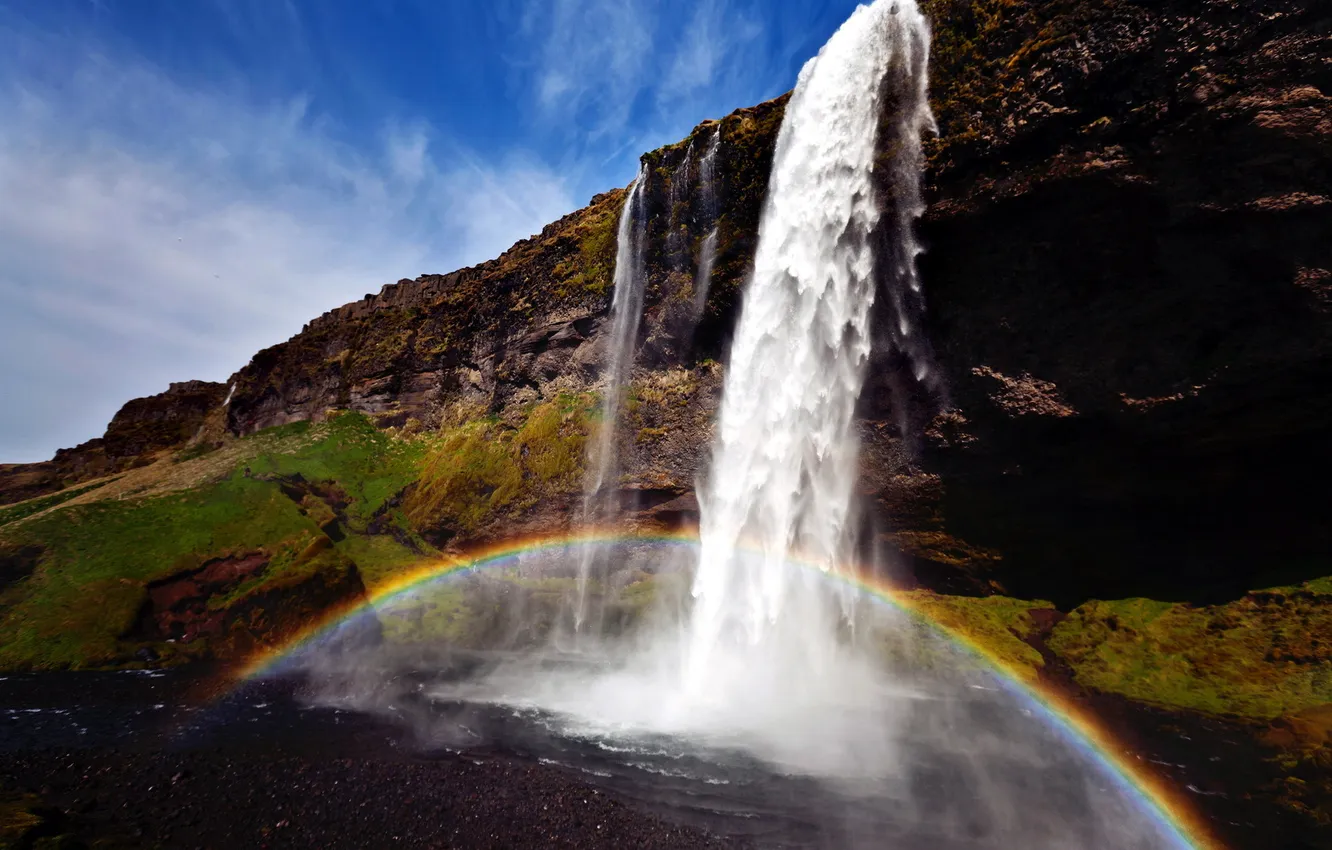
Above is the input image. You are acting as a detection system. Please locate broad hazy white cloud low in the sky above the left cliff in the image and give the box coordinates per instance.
[0,33,574,461]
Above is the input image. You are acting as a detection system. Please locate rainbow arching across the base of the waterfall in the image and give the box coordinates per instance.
[232,532,1224,850]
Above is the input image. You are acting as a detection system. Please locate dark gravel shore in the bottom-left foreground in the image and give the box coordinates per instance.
[0,750,734,850]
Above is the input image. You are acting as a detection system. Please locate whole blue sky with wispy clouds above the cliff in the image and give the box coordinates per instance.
[0,0,855,462]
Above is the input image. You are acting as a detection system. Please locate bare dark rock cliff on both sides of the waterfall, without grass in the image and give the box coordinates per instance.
[0,0,1332,605]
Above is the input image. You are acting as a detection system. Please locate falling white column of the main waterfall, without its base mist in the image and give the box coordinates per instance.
[685,0,930,690]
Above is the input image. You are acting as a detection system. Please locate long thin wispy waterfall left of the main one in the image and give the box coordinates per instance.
[574,167,647,632]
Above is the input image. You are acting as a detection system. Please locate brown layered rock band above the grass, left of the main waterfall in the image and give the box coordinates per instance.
[218,99,785,442]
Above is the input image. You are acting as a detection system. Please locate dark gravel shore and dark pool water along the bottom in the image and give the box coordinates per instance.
[0,671,1319,850]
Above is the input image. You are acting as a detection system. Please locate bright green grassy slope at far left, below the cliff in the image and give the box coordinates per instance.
[0,414,425,669]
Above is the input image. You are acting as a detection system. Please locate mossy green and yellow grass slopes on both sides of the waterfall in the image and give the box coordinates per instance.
[0,413,1332,788]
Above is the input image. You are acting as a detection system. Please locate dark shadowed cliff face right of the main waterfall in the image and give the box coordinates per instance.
[922,1,1332,602]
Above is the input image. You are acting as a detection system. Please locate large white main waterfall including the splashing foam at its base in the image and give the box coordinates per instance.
[469,0,928,781]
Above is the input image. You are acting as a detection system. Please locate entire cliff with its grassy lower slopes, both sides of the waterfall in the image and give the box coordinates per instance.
[0,0,1332,846]
